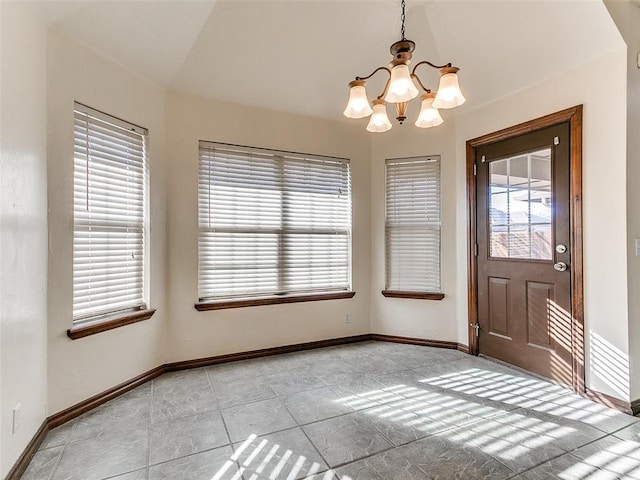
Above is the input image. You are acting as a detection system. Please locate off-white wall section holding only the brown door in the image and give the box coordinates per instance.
[455,48,629,400]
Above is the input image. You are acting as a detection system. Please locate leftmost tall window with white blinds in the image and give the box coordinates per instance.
[73,103,147,326]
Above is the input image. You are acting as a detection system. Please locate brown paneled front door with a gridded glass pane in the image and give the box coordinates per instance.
[475,123,573,385]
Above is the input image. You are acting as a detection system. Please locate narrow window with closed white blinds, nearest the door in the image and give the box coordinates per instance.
[385,156,441,293]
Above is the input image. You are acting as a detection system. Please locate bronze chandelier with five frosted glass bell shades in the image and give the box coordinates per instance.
[343,0,465,132]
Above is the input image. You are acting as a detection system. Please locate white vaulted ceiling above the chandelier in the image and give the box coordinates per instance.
[28,0,624,119]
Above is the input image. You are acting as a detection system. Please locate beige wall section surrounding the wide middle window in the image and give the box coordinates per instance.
[165,93,370,361]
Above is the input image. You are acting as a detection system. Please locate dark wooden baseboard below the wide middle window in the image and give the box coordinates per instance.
[164,334,371,372]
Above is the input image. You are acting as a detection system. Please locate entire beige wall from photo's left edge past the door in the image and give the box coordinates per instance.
[0,10,640,474]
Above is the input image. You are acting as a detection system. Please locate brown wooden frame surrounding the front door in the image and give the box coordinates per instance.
[467,105,585,393]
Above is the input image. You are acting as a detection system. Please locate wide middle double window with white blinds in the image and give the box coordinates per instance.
[198,141,351,301]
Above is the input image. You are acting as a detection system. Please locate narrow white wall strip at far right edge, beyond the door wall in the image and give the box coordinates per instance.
[606,0,640,400]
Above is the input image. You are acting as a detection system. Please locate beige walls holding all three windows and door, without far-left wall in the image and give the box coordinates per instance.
[37,24,628,412]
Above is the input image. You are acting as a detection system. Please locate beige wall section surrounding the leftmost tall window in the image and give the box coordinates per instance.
[47,32,166,414]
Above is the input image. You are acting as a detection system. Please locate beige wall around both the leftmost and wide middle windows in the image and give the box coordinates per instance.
[43,32,370,414]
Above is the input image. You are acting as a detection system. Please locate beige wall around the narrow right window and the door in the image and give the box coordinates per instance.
[371,49,628,400]
